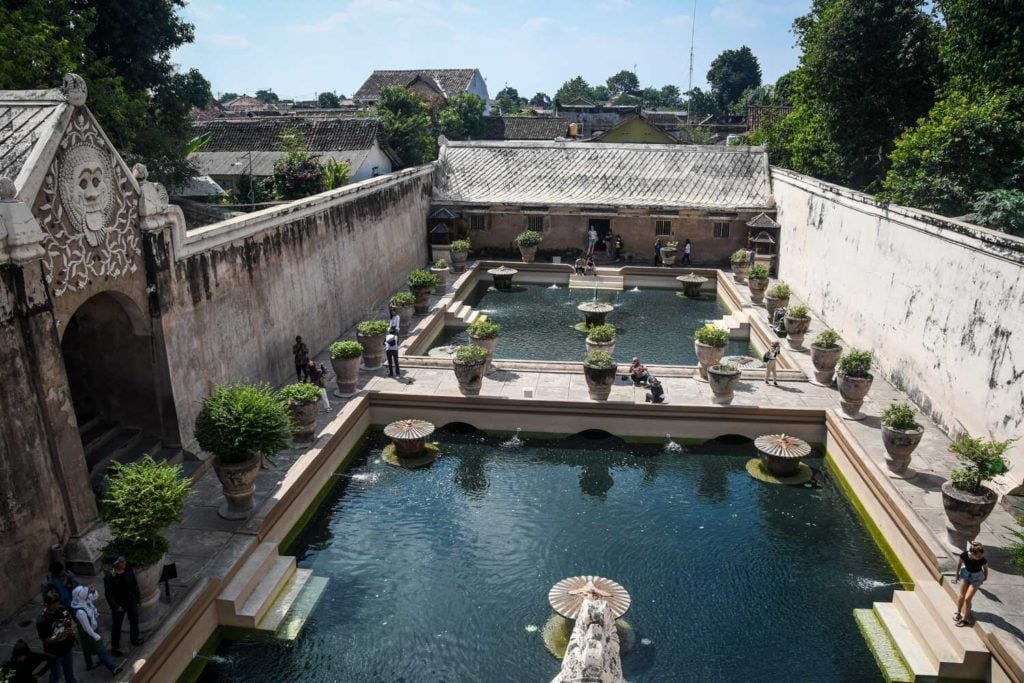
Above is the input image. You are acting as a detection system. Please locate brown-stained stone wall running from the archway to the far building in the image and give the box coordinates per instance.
[158,166,433,451]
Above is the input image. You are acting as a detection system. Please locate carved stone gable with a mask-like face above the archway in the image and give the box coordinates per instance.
[34,108,142,297]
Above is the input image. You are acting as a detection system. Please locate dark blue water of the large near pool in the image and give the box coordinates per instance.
[202,432,897,683]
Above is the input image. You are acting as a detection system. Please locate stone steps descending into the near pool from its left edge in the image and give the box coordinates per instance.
[216,543,328,640]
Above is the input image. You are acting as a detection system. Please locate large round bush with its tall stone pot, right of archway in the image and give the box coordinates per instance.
[196,384,292,519]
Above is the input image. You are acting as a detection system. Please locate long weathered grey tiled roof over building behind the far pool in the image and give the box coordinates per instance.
[434,141,772,209]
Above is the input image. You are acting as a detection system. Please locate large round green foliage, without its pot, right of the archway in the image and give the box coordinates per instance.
[196,383,292,464]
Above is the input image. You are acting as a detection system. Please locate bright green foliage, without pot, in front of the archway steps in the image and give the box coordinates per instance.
[102,454,191,566]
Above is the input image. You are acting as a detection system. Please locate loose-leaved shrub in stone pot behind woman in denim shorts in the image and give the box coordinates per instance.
[942,434,1013,547]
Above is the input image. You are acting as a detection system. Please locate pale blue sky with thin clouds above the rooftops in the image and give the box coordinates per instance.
[173,0,810,99]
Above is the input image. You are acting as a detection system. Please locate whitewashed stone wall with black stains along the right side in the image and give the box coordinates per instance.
[772,168,1024,484]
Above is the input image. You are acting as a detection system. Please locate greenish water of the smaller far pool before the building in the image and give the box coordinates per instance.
[432,282,750,366]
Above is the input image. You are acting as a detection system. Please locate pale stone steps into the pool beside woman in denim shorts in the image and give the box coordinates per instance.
[855,582,991,681]
